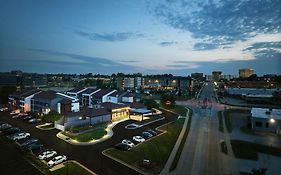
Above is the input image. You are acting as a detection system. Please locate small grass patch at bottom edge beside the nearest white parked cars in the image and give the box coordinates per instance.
[50,161,91,175]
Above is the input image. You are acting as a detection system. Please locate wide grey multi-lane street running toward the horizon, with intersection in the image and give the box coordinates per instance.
[171,84,234,175]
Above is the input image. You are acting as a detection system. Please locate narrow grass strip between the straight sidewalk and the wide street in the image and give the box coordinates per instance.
[169,109,192,171]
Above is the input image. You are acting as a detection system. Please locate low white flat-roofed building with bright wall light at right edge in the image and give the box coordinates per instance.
[251,108,281,134]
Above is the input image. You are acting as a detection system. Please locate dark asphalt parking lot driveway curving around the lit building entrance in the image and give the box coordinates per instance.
[0,111,177,175]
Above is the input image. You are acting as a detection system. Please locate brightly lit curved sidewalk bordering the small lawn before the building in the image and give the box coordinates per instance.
[56,118,129,146]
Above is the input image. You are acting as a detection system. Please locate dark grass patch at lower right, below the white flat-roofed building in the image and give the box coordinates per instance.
[231,140,281,160]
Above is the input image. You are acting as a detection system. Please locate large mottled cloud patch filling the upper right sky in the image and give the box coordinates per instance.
[150,0,281,45]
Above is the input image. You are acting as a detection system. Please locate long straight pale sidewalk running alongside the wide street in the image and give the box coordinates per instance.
[160,108,190,175]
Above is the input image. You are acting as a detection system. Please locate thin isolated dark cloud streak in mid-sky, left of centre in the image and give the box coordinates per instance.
[74,31,144,42]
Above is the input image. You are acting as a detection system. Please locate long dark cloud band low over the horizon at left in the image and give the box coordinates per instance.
[23,49,139,74]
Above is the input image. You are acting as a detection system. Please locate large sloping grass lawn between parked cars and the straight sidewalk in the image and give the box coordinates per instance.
[106,119,184,172]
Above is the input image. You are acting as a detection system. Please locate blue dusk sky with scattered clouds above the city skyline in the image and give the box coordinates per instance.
[0,0,281,75]
